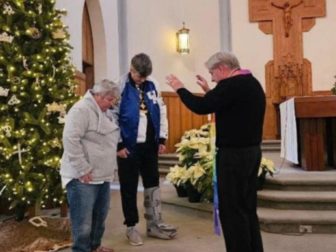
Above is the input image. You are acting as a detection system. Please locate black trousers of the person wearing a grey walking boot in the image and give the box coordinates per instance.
[118,143,159,227]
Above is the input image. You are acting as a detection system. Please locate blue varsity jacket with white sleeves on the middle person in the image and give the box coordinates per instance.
[118,74,168,151]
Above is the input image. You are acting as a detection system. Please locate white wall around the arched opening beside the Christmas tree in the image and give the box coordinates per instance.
[56,0,119,80]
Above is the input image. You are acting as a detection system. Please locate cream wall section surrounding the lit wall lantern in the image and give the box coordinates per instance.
[127,0,220,92]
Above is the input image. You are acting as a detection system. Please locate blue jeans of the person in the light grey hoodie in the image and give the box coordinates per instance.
[66,179,110,252]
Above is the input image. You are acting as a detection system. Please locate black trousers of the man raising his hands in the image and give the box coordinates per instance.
[216,146,263,252]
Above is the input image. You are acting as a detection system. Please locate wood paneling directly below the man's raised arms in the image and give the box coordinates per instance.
[162,92,208,153]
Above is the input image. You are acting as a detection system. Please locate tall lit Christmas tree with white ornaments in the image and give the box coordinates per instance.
[0,0,78,217]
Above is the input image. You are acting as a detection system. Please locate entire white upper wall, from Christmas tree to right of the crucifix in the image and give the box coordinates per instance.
[57,0,336,92]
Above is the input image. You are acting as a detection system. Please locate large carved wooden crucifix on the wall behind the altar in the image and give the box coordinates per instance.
[249,0,326,139]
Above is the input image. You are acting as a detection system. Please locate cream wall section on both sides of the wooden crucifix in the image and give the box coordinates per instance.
[231,0,336,90]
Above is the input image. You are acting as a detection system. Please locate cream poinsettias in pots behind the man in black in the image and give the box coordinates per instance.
[167,124,275,199]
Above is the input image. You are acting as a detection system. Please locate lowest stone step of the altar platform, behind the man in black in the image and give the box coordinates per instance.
[161,182,336,235]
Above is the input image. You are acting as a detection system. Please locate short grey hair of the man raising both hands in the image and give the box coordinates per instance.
[205,52,240,70]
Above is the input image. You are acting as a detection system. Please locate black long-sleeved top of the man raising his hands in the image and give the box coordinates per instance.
[177,74,266,148]
